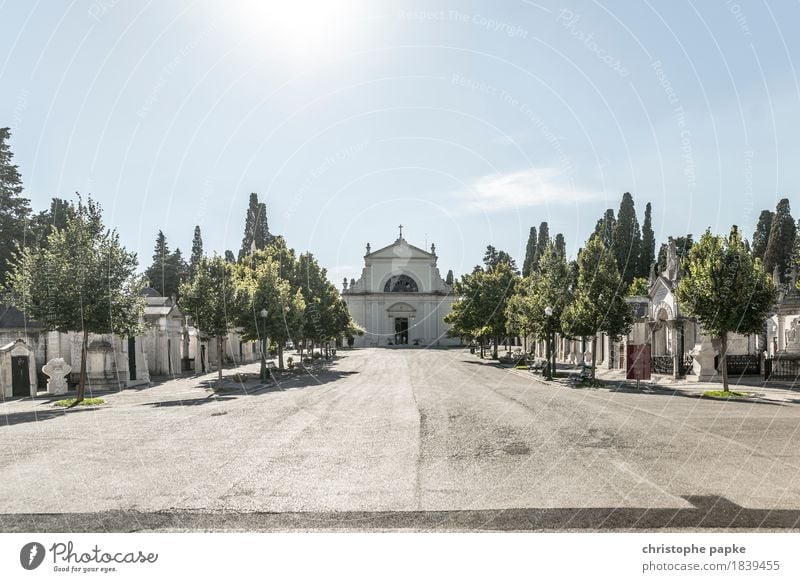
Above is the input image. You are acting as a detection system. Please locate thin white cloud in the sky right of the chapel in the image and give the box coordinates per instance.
[457,168,605,212]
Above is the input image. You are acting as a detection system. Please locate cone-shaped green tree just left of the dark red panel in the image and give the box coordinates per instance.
[561,235,633,378]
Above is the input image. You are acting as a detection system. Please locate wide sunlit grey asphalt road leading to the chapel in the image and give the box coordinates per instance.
[0,349,800,531]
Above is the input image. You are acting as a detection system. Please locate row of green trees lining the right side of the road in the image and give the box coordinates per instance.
[446,193,776,391]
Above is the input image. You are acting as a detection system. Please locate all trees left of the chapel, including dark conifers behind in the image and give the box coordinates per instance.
[0,128,359,401]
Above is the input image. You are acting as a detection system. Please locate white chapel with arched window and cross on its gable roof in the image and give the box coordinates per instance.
[342,226,459,347]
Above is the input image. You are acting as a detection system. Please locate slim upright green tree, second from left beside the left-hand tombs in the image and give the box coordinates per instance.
[178,254,236,386]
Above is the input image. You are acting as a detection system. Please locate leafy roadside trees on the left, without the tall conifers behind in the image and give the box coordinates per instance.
[6,192,358,401]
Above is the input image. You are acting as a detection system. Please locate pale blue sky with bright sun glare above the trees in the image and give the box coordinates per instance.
[0,0,800,284]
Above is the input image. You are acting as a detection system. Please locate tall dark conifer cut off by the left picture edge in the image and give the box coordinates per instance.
[0,127,31,288]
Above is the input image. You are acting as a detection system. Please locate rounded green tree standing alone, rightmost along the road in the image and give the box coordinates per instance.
[675,226,776,392]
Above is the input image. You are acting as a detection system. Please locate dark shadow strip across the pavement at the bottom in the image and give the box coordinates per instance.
[0,496,800,533]
